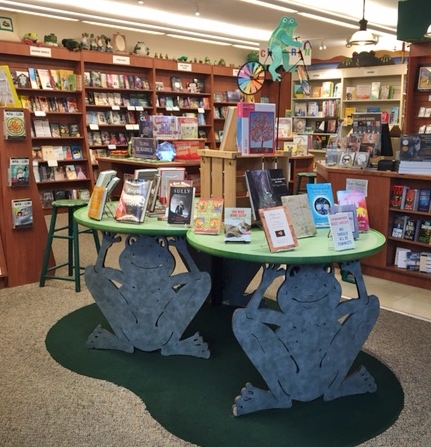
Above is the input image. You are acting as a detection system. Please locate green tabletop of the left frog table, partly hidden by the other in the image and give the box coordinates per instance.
[73,203,189,236]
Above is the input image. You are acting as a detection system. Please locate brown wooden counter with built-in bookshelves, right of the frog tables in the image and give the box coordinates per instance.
[317,162,431,290]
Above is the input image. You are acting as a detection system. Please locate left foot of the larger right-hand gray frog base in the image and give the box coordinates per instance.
[232,383,292,416]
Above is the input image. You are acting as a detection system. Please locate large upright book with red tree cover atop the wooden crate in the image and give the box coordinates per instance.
[237,102,275,155]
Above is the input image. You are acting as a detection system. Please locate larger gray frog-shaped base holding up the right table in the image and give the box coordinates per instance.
[232,261,379,416]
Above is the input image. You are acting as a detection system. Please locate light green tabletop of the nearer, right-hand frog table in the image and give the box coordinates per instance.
[187,228,386,265]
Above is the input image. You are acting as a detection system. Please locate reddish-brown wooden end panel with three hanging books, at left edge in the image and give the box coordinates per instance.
[0,107,54,287]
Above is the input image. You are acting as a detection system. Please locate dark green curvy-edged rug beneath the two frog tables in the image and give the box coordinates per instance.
[46,304,404,447]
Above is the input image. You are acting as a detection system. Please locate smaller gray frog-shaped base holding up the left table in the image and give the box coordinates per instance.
[85,232,211,358]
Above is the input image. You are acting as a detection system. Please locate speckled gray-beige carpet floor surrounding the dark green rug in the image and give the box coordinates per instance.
[0,215,431,447]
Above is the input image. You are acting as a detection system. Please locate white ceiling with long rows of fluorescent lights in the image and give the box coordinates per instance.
[0,0,400,49]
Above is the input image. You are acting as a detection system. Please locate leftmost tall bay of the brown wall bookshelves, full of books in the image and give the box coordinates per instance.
[0,42,92,209]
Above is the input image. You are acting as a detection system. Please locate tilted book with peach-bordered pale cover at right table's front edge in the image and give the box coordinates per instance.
[259,206,298,252]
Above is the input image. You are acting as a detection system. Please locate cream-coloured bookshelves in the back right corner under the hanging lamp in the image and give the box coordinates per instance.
[292,64,409,160]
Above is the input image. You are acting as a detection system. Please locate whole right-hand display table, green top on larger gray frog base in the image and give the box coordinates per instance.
[187,229,385,416]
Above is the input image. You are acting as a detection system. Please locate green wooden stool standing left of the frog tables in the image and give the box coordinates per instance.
[39,200,100,292]
